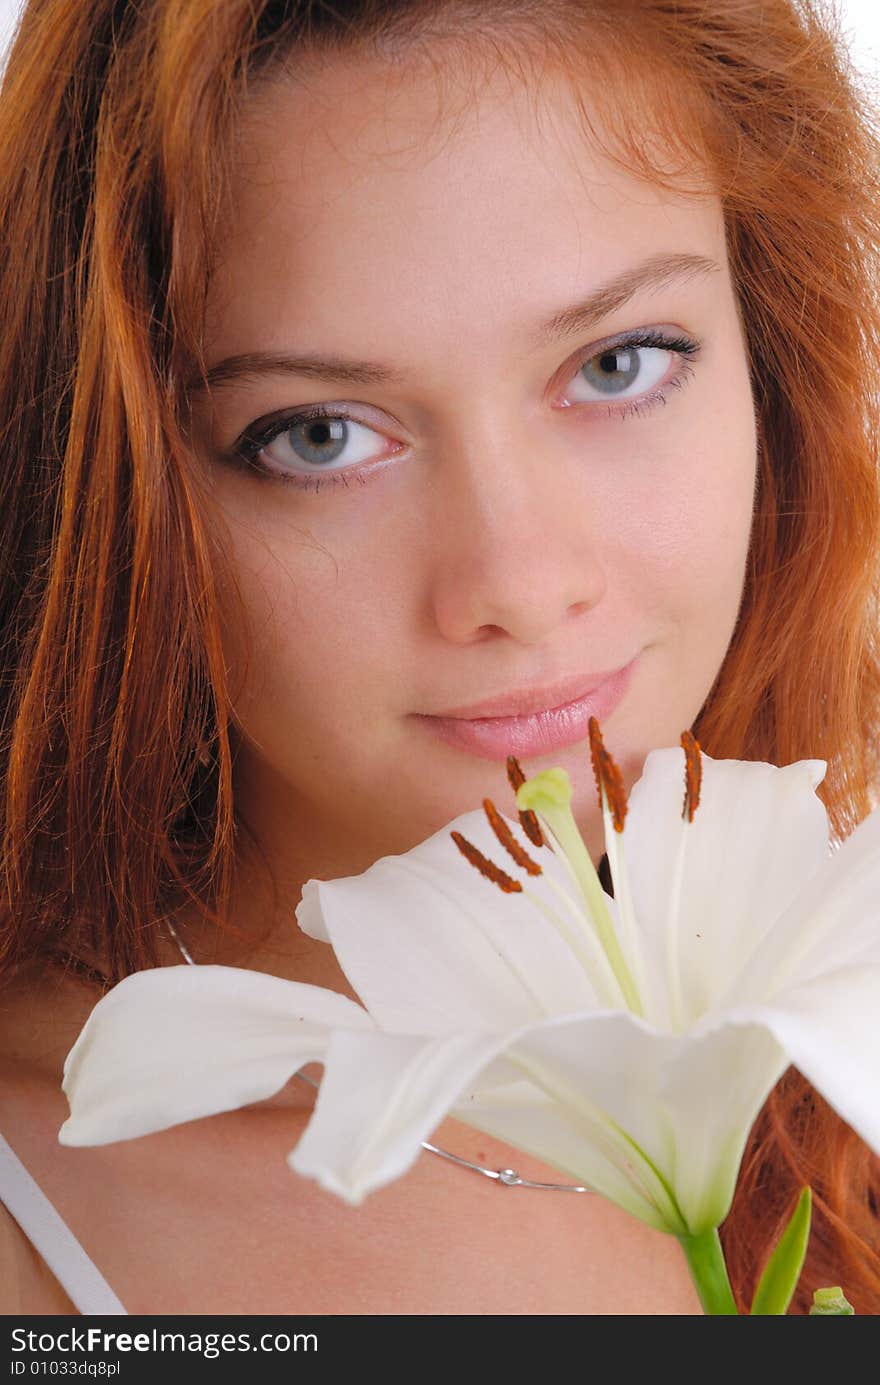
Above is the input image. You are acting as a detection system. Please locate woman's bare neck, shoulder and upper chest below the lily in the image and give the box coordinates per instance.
[0,969,700,1316]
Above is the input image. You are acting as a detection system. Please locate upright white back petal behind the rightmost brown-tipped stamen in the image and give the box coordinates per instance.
[624,749,829,1028]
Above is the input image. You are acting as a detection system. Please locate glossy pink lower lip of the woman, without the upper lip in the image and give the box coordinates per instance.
[419,659,636,760]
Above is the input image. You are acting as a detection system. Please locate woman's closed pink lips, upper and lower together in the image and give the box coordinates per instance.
[419,659,636,760]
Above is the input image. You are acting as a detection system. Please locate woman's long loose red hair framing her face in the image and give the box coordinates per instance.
[0,0,880,1313]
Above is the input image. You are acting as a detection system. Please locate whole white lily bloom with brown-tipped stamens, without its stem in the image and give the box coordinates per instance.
[60,723,880,1263]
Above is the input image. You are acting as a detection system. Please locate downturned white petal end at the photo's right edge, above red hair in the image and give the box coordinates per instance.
[741,958,880,1154]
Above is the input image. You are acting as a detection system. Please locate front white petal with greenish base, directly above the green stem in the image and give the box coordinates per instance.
[498,1012,787,1234]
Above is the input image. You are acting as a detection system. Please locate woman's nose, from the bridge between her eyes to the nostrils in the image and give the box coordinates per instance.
[428,416,607,645]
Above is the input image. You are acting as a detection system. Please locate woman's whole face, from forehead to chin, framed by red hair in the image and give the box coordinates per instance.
[192,48,755,875]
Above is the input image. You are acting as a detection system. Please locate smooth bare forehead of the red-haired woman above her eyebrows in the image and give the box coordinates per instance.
[206,47,723,359]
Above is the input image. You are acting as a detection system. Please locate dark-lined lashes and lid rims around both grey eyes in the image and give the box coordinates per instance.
[230,328,701,494]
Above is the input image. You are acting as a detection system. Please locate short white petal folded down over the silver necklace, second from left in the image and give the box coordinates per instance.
[288,1032,506,1204]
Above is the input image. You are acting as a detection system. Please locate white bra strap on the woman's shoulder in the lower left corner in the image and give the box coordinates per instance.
[0,1134,127,1317]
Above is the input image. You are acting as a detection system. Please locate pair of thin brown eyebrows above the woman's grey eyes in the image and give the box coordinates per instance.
[194,255,721,388]
